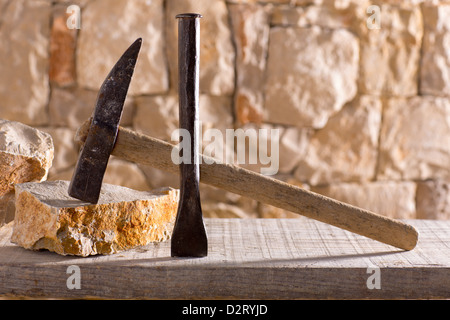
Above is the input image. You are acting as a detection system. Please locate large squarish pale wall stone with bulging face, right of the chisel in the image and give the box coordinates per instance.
[265,27,359,128]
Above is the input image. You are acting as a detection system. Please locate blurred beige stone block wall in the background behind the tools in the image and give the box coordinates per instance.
[0,0,450,219]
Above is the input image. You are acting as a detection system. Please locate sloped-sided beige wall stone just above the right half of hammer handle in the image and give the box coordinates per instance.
[295,96,382,185]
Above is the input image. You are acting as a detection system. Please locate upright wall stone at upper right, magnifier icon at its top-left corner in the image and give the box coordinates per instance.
[358,3,423,96]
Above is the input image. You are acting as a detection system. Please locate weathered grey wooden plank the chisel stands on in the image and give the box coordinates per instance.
[0,218,450,299]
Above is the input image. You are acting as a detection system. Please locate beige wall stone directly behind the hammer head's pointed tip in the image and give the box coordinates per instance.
[77,0,168,95]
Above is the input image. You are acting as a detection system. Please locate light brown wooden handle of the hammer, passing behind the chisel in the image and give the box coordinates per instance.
[77,122,418,250]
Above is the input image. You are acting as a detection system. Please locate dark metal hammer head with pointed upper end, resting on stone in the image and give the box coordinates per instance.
[69,38,142,203]
